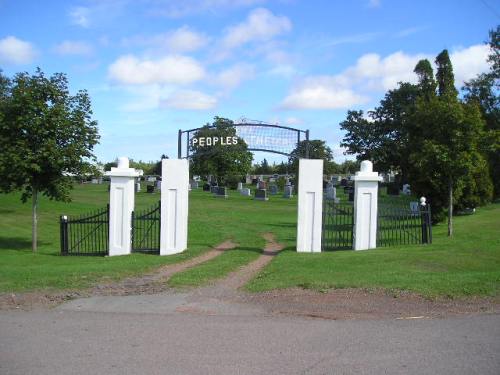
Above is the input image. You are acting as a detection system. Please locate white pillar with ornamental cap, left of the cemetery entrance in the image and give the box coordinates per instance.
[106,157,142,256]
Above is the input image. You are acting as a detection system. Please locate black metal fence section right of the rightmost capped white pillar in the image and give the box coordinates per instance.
[377,202,432,247]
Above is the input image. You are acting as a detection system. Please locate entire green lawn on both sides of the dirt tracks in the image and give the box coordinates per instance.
[0,185,500,297]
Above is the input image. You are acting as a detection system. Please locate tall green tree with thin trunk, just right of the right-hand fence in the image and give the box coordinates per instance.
[410,50,492,236]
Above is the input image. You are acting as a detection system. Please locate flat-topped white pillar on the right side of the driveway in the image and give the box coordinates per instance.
[297,159,323,253]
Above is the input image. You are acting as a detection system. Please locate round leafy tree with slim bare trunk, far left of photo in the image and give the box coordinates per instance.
[0,68,99,251]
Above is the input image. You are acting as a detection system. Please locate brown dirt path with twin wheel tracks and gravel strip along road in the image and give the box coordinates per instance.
[0,233,500,319]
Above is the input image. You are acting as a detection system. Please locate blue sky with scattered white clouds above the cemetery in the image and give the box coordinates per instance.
[0,0,500,162]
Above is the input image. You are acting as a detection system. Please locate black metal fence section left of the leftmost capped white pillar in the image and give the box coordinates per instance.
[60,205,109,255]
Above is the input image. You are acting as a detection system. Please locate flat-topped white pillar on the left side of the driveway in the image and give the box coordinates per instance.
[160,159,189,255]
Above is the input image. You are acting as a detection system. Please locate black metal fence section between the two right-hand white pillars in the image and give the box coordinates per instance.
[321,199,354,251]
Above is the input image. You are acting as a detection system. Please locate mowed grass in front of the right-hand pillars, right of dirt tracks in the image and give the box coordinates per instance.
[247,204,500,298]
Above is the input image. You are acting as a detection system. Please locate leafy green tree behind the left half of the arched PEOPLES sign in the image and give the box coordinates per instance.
[189,117,253,184]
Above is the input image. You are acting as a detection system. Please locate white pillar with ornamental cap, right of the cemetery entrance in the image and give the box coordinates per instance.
[354,160,382,250]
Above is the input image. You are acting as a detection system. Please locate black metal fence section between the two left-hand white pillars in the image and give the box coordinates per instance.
[132,201,161,254]
